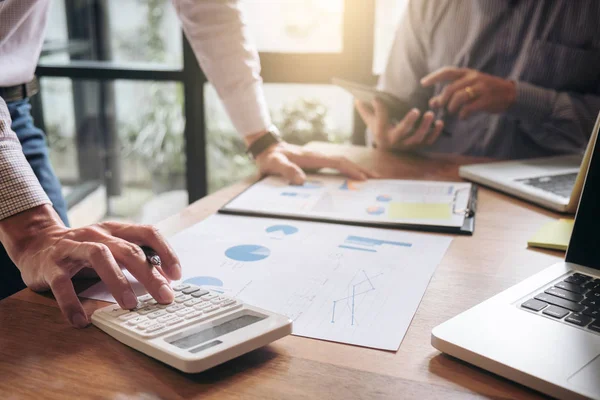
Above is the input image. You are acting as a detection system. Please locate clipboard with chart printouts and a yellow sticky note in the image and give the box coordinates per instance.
[220,175,476,233]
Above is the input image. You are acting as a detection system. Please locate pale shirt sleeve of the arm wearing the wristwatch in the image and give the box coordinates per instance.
[172,0,271,135]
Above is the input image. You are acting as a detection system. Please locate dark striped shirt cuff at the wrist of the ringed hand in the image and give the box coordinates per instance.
[506,81,554,121]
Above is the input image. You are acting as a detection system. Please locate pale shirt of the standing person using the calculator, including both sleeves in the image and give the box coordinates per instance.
[0,0,271,220]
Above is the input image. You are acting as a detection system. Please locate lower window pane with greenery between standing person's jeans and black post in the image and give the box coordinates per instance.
[41,78,188,226]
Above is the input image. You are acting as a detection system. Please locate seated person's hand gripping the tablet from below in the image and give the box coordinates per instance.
[355,99,444,150]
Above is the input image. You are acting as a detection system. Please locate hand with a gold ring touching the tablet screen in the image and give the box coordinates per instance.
[421,67,517,119]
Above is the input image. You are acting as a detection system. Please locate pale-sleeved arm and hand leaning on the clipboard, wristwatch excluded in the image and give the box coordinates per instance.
[172,0,374,184]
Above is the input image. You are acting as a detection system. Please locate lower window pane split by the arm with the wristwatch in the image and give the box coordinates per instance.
[205,84,353,192]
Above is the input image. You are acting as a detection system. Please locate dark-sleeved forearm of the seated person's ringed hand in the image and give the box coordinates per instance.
[506,82,600,152]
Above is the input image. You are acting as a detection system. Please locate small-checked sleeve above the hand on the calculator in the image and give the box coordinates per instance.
[0,97,50,220]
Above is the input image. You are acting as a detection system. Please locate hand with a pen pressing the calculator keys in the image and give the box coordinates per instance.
[0,205,181,328]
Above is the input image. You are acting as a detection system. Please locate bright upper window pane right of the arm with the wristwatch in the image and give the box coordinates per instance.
[242,0,344,53]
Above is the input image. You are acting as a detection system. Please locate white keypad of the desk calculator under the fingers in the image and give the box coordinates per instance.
[100,284,242,339]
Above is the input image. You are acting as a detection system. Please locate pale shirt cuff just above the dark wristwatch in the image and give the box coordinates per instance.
[222,82,271,136]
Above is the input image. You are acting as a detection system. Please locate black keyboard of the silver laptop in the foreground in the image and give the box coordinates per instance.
[521,273,600,332]
